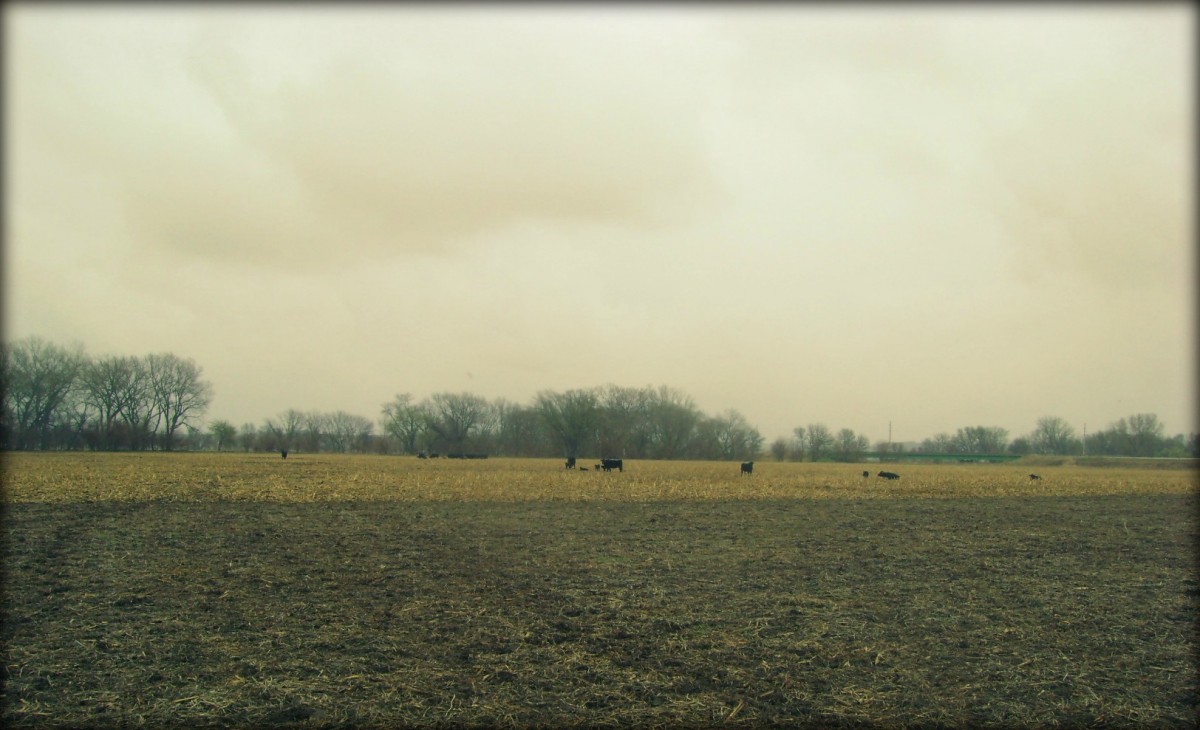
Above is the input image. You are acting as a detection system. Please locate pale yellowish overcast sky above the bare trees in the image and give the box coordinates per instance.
[2,2,1198,442]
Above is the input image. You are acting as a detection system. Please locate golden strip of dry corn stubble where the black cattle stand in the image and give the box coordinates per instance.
[4,453,1200,502]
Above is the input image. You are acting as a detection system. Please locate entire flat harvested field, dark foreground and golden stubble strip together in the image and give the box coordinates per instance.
[0,454,1200,728]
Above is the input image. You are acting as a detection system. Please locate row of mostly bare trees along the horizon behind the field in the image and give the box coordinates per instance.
[0,336,1200,461]
